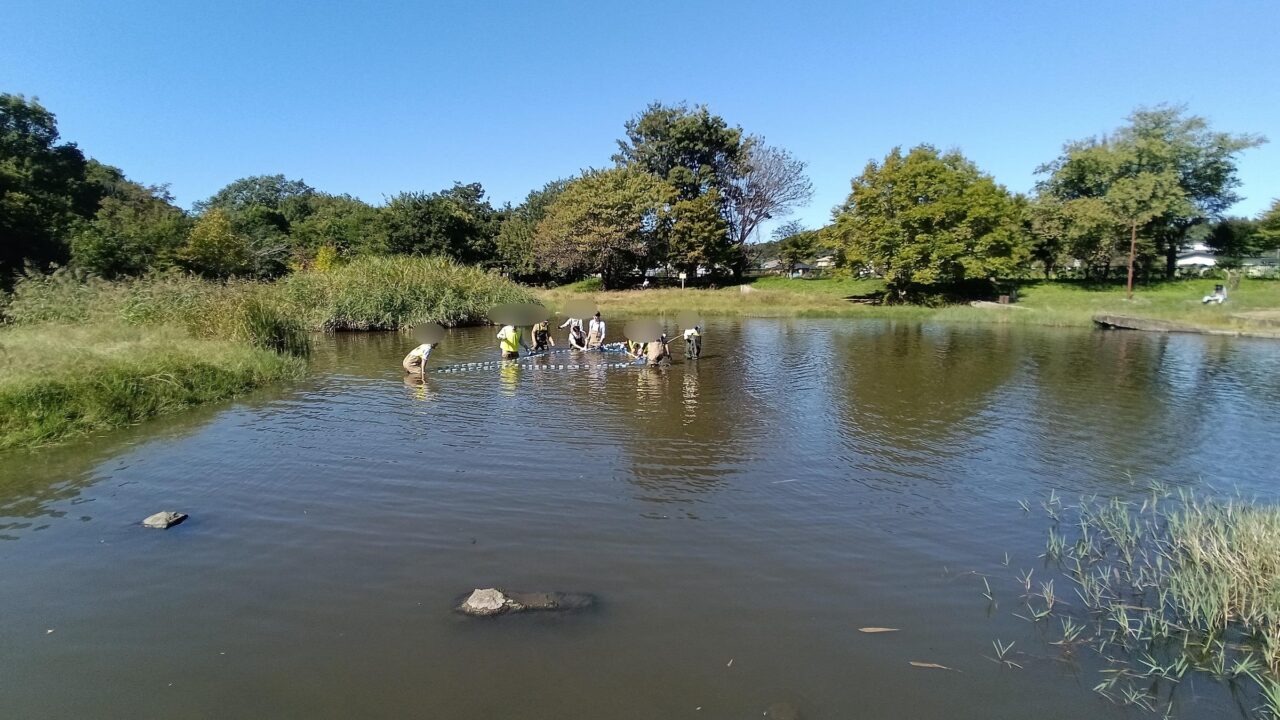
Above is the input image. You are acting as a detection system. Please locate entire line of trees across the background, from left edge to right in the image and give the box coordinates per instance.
[0,95,1280,297]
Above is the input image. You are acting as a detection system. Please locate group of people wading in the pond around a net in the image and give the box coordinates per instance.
[401,307,703,373]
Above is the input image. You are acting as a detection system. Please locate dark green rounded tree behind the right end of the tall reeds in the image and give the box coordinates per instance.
[379,183,499,264]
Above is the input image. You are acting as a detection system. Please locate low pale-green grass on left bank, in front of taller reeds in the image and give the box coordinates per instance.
[0,322,303,450]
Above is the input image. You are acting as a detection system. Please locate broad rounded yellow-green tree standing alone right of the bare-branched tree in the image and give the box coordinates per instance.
[828,145,1029,300]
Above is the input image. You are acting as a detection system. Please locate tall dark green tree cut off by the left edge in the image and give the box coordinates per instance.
[0,94,101,287]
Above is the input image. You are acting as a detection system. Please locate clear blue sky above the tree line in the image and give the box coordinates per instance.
[0,0,1280,235]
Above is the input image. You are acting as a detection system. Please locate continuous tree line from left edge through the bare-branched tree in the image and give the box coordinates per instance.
[0,95,812,287]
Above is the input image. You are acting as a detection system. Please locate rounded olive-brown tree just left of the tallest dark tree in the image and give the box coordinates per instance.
[534,168,676,288]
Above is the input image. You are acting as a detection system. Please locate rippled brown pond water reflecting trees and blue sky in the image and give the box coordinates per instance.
[0,320,1280,720]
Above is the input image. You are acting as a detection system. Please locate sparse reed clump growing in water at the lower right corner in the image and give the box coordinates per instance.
[1008,486,1280,717]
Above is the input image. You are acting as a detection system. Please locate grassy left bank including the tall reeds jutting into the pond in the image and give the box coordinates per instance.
[0,258,532,450]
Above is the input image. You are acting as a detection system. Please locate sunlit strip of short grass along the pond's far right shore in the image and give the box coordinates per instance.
[540,278,1280,329]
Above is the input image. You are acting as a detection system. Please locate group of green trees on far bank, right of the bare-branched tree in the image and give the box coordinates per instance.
[817,105,1280,297]
